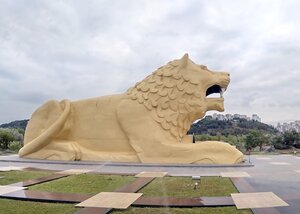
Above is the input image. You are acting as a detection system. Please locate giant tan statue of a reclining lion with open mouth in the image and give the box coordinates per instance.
[19,54,243,163]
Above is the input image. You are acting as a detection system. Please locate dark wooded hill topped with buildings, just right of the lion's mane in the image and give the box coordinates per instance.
[189,116,277,136]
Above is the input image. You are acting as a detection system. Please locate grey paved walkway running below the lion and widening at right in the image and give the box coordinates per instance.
[0,155,300,214]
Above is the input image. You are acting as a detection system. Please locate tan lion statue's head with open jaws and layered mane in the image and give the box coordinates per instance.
[127,54,230,142]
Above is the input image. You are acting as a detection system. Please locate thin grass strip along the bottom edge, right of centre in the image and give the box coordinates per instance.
[111,206,252,214]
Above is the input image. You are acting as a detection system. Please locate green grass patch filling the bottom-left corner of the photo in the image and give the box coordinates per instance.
[0,198,78,214]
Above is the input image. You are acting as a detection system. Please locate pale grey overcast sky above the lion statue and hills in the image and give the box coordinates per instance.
[0,0,300,124]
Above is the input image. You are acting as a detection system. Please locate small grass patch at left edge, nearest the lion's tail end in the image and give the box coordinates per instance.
[0,171,52,185]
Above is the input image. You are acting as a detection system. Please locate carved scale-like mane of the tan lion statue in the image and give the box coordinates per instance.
[127,56,207,142]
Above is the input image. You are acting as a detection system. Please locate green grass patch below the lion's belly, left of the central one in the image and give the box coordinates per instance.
[29,174,135,194]
